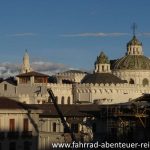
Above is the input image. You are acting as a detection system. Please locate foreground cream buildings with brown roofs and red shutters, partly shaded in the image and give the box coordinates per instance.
[0,97,95,150]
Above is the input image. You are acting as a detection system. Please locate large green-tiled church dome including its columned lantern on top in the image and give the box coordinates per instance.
[112,35,150,70]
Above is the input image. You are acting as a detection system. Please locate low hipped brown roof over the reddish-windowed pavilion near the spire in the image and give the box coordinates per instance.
[17,71,49,77]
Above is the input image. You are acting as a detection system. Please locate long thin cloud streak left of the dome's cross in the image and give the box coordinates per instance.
[60,32,129,37]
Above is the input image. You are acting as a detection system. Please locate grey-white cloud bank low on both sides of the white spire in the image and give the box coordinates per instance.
[0,61,69,78]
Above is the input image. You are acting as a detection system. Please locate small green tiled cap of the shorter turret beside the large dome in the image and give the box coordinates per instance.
[95,52,109,64]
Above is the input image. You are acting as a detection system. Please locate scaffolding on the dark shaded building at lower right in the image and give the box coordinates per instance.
[103,102,149,141]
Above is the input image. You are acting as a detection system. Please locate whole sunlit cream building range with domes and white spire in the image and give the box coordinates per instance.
[0,35,150,104]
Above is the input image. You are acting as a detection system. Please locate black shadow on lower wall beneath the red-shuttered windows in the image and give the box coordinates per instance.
[0,130,38,150]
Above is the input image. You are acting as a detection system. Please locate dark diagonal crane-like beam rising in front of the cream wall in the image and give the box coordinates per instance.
[47,88,77,142]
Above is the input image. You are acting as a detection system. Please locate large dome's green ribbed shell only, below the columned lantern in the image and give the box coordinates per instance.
[112,55,150,70]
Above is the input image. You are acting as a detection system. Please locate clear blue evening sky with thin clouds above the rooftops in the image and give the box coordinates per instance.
[0,0,150,75]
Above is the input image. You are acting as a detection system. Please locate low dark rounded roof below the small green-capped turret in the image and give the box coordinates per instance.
[81,73,127,84]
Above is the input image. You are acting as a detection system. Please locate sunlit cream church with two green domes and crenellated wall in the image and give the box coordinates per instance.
[73,35,150,104]
